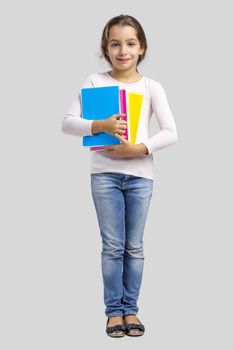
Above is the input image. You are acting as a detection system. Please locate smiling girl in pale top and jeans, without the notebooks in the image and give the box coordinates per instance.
[62,15,177,337]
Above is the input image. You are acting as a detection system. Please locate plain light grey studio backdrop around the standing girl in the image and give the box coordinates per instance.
[0,0,233,350]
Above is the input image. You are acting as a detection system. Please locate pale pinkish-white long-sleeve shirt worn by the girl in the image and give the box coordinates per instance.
[62,72,177,180]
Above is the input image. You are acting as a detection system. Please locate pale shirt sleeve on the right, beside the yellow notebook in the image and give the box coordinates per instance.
[143,80,178,154]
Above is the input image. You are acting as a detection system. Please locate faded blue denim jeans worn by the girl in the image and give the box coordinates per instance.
[91,173,153,317]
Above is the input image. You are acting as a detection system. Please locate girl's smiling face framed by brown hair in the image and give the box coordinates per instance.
[107,25,144,71]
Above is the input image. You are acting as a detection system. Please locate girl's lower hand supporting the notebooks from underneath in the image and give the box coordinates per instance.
[103,134,148,158]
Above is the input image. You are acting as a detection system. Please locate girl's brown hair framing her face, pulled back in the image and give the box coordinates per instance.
[100,15,147,65]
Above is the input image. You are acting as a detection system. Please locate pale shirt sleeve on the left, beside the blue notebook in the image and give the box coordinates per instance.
[62,76,93,136]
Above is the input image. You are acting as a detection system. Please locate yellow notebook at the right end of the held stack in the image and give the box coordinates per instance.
[128,92,143,145]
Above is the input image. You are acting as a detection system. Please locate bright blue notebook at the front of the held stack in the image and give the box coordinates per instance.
[81,86,120,146]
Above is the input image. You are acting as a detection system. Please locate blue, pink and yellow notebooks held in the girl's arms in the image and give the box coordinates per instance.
[81,86,143,151]
